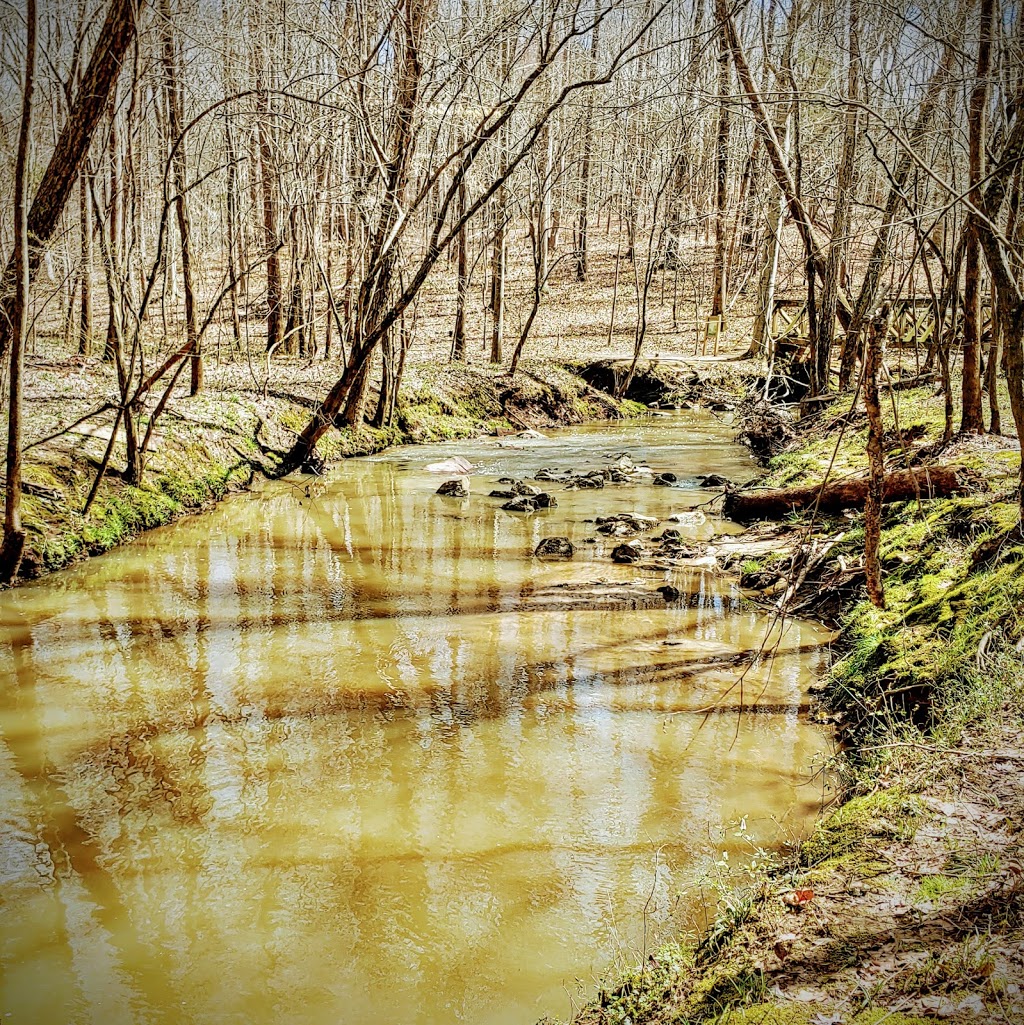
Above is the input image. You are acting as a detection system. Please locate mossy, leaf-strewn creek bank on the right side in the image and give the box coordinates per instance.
[561,379,1024,1025]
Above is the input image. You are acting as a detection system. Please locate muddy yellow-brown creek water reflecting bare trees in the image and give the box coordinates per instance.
[0,414,828,1025]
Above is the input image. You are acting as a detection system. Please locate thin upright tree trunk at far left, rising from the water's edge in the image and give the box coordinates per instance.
[0,0,36,583]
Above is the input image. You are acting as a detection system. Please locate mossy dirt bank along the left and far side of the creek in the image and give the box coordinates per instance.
[0,358,644,579]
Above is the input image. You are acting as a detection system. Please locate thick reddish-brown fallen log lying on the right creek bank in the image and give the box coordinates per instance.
[724,466,974,523]
